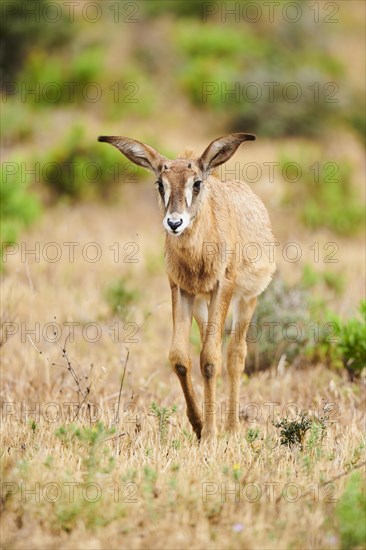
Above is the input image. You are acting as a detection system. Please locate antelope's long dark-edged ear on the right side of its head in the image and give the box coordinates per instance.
[198,134,256,173]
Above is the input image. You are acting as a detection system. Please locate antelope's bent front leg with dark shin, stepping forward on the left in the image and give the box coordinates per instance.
[169,282,202,439]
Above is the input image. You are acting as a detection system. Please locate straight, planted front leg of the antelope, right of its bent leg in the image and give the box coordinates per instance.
[200,281,233,439]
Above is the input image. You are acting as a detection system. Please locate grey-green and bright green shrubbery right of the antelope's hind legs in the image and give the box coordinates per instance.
[246,269,366,380]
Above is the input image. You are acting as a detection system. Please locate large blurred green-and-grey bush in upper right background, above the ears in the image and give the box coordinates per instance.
[173,22,351,137]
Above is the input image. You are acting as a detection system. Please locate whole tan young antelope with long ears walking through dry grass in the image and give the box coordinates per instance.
[99,133,275,439]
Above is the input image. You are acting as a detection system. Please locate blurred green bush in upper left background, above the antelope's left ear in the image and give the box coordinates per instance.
[13,42,159,120]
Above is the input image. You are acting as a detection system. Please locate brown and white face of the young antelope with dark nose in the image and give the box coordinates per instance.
[156,159,203,236]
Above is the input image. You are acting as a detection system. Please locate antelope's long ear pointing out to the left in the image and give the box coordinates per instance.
[98,136,167,174]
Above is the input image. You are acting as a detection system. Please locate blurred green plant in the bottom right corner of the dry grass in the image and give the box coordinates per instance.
[336,472,366,550]
